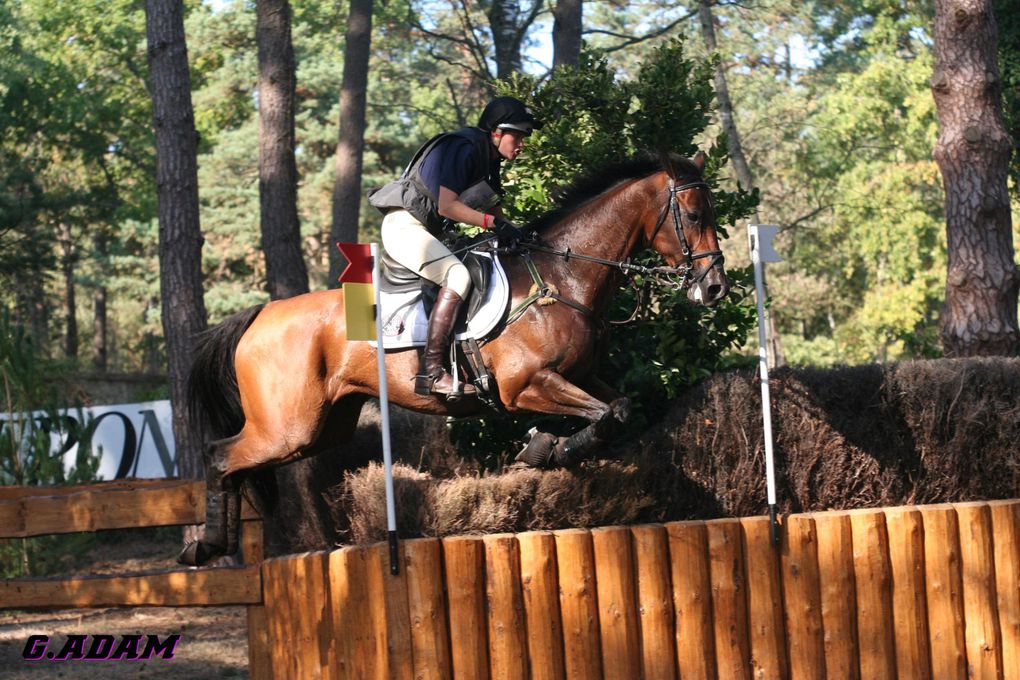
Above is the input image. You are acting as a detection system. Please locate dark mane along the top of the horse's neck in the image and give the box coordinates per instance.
[528,153,701,231]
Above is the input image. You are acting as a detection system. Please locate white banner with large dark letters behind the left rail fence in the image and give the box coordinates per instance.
[0,400,177,480]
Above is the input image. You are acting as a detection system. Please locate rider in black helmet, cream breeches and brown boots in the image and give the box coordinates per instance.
[368,97,542,397]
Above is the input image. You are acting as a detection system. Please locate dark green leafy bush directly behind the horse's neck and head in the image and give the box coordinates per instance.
[452,40,757,456]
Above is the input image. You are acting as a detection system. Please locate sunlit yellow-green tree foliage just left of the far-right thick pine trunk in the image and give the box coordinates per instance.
[772,40,946,363]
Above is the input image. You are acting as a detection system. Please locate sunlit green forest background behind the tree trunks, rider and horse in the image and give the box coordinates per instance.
[0,0,1020,372]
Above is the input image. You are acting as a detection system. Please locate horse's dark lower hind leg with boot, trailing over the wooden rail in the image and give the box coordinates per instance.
[177,435,241,567]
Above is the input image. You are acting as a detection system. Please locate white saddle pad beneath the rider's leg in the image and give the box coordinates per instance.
[371,251,510,350]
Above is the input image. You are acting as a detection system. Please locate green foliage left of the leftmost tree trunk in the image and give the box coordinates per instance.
[0,0,155,360]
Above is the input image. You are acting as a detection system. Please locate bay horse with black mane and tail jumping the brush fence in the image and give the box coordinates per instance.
[179,153,729,565]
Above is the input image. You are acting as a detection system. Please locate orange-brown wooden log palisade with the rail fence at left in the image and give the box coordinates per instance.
[0,481,1020,680]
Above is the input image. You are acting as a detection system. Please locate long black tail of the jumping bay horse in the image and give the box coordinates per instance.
[188,305,265,440]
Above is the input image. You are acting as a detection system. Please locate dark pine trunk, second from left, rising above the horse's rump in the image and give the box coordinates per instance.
[255,0,308,300]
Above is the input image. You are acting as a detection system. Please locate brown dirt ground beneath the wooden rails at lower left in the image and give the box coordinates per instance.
[0,531,248,680]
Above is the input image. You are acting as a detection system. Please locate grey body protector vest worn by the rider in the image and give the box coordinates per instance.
[368,127,503,234]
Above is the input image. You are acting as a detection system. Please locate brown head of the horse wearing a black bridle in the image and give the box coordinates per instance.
[645,152,729,307]
